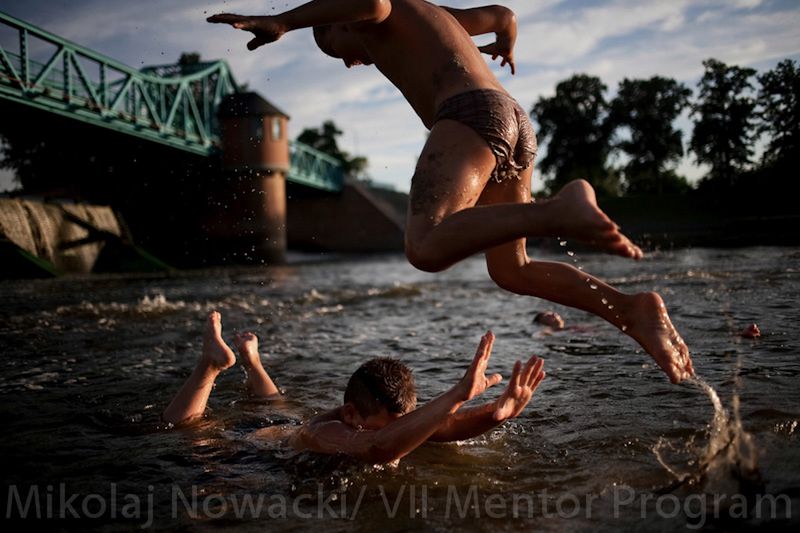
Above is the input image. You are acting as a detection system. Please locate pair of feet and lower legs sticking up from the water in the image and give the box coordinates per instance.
[161,311,280,424]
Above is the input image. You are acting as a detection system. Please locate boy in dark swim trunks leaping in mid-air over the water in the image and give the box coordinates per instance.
[208,0,694,383]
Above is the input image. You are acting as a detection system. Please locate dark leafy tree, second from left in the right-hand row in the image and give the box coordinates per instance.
[609,76,692,194]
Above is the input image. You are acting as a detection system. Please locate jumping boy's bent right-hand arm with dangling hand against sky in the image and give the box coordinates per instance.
[442,5,517,74]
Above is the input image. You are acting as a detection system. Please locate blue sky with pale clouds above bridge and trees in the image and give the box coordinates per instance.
[0,0,800,191]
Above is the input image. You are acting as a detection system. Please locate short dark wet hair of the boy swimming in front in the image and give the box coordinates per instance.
[344,357,417,417]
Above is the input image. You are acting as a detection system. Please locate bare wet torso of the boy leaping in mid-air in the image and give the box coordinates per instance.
[350,0,505,128]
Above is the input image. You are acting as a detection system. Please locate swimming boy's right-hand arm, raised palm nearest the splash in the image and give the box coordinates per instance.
[428,355,545,442]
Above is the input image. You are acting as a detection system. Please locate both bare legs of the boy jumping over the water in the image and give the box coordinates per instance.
[406,120,694,383]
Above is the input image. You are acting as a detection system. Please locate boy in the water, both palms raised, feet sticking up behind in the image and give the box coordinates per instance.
[162,311,545,463]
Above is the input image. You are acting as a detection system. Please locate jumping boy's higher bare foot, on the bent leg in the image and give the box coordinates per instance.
[550,180,643,259]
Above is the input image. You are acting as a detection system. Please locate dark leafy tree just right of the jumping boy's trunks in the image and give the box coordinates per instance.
[531,74,619,195]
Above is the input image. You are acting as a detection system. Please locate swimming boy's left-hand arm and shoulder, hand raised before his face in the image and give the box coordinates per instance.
[292,333,502,463]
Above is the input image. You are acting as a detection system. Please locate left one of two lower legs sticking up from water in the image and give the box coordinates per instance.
[161,311,236,424]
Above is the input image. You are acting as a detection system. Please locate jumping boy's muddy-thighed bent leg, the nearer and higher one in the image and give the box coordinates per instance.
[406,120,641,271]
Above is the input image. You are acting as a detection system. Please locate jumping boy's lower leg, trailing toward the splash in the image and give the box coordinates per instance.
[480,175,694,382]
